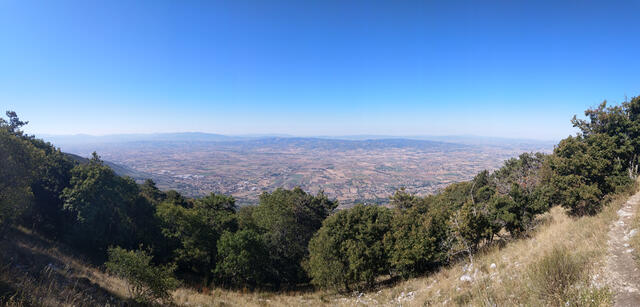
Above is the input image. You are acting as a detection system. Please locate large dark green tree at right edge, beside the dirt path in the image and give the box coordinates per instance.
[549,97,640,215]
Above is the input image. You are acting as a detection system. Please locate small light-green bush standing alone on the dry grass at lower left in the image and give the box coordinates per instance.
[105,247,179,303]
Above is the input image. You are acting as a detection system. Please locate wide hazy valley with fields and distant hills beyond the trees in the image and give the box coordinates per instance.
[45,133,553,207]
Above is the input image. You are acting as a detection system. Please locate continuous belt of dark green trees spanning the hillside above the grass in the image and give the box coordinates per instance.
[0,97,640,305]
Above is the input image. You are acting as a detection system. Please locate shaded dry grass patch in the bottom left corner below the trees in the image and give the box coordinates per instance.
[0,228,128,306]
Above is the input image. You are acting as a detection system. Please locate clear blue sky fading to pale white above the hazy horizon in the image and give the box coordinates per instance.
[0,0,640,139]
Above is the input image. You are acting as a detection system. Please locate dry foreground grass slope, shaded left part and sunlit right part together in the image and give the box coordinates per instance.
[0,189,628,306]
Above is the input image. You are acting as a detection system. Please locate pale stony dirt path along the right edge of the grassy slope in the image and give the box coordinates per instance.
[605,193,640,306]
